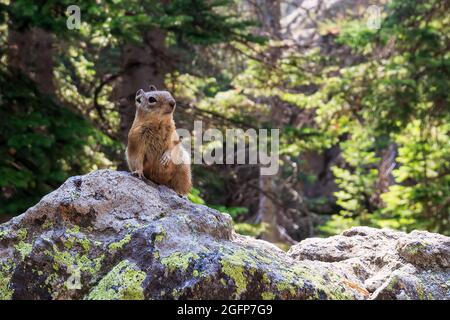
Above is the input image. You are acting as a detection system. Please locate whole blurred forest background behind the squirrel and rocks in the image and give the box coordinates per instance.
[0,0,450,248]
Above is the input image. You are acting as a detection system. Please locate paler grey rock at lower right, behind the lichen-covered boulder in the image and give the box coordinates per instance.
[288,227,450,299]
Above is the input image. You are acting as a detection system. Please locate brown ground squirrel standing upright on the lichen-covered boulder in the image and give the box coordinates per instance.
[126,86,192,195]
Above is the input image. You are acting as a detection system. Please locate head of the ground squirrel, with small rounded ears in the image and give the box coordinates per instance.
[136,86,176,117]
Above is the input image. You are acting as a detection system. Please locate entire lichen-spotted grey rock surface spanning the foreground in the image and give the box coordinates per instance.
[0,170,450,299]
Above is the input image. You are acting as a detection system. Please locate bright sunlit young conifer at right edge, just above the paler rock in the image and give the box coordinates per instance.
[376,120,450,234]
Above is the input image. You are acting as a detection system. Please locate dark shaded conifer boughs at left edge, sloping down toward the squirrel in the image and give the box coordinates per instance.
[0,70,113,214]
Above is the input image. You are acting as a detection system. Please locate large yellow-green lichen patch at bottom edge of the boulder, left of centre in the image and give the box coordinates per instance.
[87,260,146,300]
